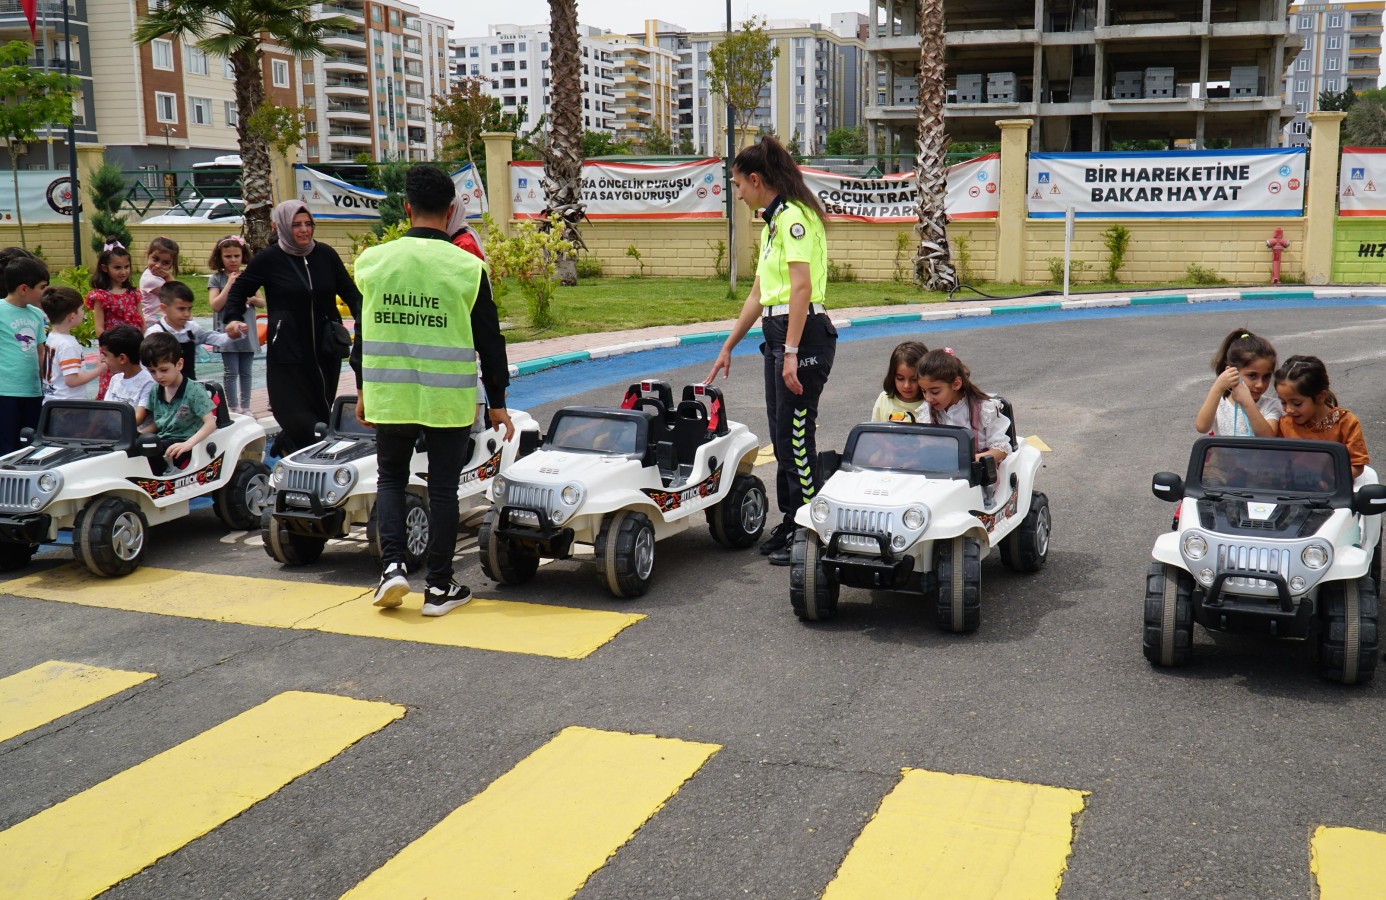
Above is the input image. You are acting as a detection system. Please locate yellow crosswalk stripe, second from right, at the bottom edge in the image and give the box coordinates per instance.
[823,768,1087,900]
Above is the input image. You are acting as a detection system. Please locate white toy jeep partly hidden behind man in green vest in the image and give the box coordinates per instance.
[261,395,539,571]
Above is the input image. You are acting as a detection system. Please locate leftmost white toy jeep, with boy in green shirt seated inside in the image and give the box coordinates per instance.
[0,383,269,576]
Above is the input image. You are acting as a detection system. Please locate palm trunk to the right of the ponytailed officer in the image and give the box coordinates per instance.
[915,0,958,293]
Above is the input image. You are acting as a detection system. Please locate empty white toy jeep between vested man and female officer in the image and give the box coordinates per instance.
[480,381,766,598]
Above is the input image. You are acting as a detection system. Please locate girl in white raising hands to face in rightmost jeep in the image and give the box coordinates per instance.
[1193,329,1281,437]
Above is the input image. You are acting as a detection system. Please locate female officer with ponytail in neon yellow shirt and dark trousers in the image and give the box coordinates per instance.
[707,137,837,566]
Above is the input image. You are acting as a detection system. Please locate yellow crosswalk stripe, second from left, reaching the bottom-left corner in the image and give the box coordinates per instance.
[0,691,405,900]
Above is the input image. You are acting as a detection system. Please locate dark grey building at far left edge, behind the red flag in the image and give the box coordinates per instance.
[0,0,96,169]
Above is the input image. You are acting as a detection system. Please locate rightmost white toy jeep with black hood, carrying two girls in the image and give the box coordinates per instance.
[1142,437,1386,684]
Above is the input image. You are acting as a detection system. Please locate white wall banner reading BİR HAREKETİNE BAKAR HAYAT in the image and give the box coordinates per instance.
[1026,147,1307,219]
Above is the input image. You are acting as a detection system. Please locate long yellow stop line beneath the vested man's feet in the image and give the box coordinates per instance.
[0,564,644,659]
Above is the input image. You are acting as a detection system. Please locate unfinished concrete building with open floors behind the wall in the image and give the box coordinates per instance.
[866,0,1300,153]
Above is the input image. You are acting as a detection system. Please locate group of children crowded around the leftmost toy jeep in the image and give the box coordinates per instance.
[0,236,263,469]
